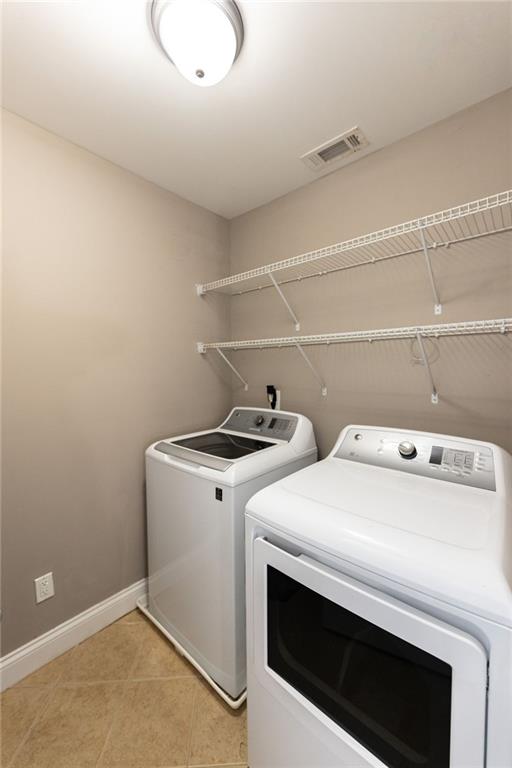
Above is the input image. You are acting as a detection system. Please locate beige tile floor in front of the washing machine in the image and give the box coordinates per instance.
[1,612,247,768]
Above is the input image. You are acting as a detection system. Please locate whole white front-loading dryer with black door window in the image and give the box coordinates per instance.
[246,426,512,768]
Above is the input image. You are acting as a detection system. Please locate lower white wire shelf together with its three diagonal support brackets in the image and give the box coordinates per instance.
[197,317,512,405]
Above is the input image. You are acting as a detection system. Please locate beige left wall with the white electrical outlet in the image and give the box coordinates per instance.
[2,113,229,654]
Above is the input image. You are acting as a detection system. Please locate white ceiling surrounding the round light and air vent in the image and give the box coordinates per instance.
[3,0,512,218]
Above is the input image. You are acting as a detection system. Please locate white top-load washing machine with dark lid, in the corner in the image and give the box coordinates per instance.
[140,408,317,707]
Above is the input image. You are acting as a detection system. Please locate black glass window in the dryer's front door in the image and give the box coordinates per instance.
[267,566,452,768]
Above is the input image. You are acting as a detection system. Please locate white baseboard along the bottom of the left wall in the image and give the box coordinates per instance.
[0,579,147,691]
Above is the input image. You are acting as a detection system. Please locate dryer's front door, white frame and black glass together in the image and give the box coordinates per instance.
[252,538,487,768]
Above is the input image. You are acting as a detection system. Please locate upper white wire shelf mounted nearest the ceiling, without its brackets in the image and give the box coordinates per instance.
[197,190,512,298]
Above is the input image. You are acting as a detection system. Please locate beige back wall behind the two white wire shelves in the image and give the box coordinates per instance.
[228,91,512,455]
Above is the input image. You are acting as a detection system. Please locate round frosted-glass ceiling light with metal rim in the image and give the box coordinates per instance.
[151,0,244,88]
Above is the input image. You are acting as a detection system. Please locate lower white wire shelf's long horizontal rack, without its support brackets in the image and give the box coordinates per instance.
[197,317,512,353]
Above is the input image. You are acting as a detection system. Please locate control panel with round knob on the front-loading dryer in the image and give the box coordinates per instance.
[334,427,496,491]
